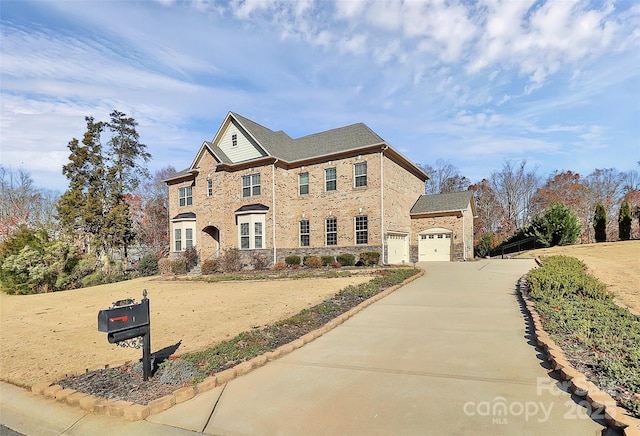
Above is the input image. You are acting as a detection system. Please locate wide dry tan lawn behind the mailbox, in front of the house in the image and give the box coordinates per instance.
[0,276,371,386]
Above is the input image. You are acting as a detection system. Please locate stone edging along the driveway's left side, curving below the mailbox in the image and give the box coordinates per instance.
[31,270,424,422]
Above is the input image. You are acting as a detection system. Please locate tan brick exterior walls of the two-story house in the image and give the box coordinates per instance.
[167,114,472,264]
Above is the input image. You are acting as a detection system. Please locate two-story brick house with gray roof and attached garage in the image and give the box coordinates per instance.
[166,112,475,264]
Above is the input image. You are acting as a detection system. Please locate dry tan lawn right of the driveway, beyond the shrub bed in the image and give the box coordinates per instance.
[525,241,640,314]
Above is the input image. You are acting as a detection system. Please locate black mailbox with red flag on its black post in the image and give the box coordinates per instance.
[98,289,151,381]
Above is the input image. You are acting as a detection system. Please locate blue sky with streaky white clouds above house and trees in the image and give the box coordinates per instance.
[0,0,640,191]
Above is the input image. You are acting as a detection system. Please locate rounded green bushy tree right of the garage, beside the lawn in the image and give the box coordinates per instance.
[527,202,582,247]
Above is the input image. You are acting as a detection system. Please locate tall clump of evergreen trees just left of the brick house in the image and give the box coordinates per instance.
[58,111,151,268]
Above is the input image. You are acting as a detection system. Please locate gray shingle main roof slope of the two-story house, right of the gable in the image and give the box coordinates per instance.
[231,112,384,162]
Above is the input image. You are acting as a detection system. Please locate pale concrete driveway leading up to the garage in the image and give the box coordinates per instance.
[0,260,604,435]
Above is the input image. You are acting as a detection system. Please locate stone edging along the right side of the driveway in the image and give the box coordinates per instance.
[518,274,640,436]
